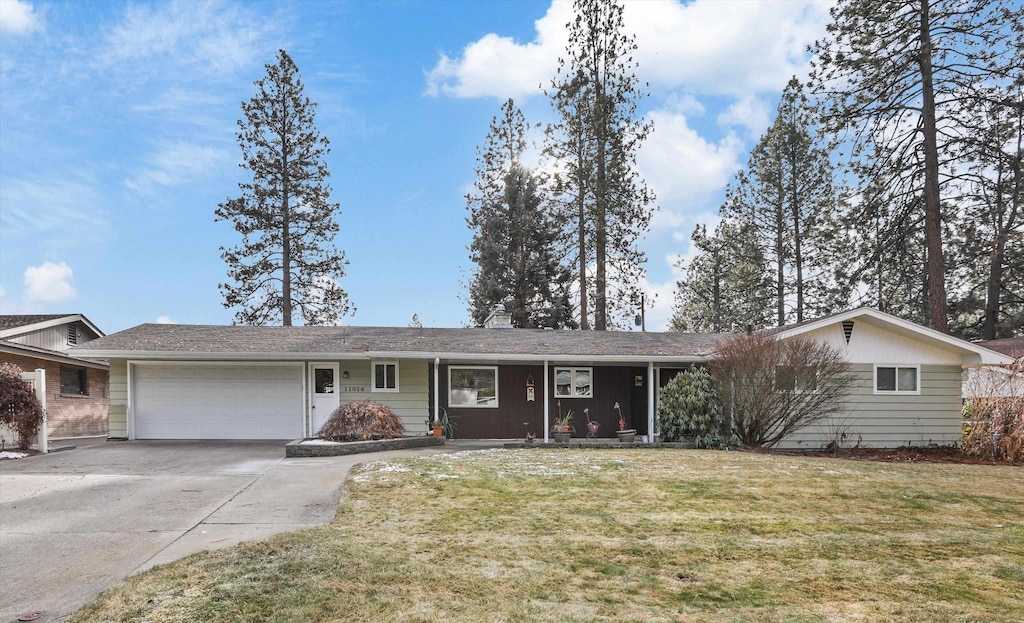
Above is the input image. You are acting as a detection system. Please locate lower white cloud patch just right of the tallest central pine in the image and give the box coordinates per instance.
[637,111,743,233]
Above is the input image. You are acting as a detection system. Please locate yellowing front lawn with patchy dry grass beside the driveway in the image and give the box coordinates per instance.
[72,450,1024,623]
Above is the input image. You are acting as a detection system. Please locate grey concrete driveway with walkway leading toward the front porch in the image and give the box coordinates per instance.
[0,440,453,623]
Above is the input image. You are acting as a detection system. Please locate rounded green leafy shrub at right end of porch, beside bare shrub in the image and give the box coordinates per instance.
[657,366,728,448]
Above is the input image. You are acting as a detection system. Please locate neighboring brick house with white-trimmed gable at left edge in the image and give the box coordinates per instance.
[0,314,110,438]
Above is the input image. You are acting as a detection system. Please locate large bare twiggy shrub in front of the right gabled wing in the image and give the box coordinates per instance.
[711,332,853,448]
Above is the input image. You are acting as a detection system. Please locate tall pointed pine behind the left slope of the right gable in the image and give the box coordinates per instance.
[723,78,847,326]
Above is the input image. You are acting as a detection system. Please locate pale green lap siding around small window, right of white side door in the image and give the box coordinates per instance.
[338,360,430,435]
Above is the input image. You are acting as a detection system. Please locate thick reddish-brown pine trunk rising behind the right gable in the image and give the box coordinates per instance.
[918,0,948,333]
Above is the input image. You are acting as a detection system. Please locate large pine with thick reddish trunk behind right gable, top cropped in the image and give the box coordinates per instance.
[812,0,1021,331]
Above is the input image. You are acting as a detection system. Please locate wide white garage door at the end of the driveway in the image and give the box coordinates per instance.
[132,365,303,440]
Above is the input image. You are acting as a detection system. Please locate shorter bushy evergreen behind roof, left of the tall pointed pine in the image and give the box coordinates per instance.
[669,220,771,333]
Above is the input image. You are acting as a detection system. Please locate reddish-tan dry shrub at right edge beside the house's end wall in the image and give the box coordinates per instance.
[963,359,1024,461]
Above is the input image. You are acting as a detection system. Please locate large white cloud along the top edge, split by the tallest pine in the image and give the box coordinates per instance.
[426,0,831,97]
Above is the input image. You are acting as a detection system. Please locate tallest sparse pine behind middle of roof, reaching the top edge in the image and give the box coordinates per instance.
[547,0,654,331]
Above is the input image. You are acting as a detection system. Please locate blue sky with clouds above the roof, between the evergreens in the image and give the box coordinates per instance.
[0,0,829,332]
